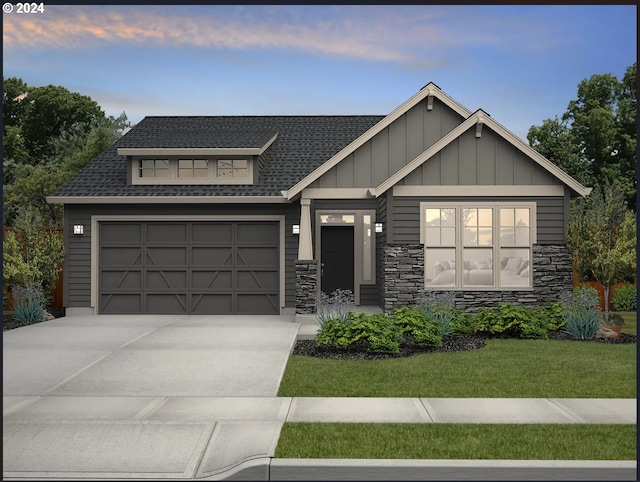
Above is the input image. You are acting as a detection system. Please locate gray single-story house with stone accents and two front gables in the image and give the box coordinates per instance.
[48,83,590,314]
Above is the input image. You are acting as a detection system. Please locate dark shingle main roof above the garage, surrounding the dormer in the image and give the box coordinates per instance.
[53,116,384,197]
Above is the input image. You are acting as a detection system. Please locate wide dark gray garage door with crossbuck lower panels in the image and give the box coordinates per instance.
[98,221,280,314]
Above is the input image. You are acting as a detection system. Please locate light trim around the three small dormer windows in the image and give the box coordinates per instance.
[129,155,256,185]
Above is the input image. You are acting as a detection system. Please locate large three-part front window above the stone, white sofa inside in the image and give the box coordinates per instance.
[421,203,535,289]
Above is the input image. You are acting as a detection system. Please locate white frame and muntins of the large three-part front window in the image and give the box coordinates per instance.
[420,201,538,291]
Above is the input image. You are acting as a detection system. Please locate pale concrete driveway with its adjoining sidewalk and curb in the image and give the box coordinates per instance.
[3,315,636,480]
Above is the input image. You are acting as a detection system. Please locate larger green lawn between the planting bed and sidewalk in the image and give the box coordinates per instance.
[278,339,636,398]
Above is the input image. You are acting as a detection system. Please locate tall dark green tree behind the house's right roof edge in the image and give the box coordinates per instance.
[527,63,637,212]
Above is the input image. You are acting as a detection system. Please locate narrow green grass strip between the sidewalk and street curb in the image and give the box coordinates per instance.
[275,423,636,460]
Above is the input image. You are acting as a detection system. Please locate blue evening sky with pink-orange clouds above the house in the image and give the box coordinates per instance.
[3,3,637,140]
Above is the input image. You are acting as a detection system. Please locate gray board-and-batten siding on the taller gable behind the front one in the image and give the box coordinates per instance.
[309,99,464,188]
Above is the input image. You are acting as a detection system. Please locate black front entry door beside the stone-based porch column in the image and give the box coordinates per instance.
[320,226,354,294]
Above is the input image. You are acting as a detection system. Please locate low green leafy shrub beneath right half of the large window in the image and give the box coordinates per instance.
[473,303,549,338]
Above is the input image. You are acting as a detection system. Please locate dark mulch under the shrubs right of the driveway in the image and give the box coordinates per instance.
[293,331,636,360]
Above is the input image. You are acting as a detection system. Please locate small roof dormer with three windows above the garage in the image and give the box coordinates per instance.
[118,132,278,185]
